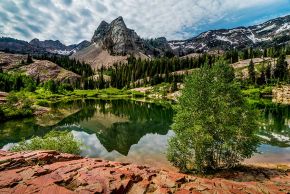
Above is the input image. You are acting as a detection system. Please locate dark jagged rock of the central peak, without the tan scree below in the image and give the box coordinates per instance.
[91,16,172,56]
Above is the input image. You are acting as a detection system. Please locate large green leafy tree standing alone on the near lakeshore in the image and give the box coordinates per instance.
[167,62,259,172]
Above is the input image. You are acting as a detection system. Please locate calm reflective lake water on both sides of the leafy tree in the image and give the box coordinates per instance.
[0,100,290,169]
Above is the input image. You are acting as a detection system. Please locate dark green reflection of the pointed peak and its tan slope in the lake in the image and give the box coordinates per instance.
[61,100,173,155]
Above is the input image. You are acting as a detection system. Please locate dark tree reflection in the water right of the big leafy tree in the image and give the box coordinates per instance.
[260,105,290,147]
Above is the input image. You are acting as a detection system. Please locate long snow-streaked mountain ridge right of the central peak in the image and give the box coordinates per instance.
[169,15,290,55]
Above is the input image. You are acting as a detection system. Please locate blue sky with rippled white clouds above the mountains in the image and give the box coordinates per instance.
[0,0,290,44]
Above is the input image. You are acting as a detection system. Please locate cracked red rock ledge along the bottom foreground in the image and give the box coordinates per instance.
[0,151,290,194]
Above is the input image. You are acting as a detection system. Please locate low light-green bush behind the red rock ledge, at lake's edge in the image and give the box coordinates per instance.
[10,131,82,155]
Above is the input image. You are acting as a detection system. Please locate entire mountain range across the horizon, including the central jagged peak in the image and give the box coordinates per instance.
[0,15,290,58]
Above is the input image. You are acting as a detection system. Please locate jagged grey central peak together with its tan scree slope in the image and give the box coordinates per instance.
[71,16,173,69]
